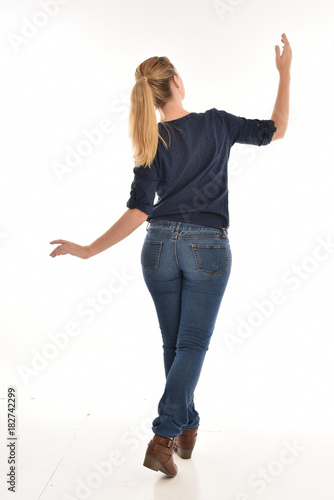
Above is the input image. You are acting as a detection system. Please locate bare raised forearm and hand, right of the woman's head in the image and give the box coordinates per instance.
[271,33,292,141]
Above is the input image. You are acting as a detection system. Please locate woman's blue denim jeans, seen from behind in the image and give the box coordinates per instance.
[141,219,232,438]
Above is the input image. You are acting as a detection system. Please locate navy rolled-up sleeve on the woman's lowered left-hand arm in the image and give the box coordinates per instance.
[126,164,158,216]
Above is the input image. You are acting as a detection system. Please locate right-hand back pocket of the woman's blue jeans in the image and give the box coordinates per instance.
[191,243,228,275]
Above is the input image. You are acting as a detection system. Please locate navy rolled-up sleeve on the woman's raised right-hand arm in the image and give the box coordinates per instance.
[220,111,277,146]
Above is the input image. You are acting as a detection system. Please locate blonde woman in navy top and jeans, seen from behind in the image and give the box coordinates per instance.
[50,33,292,477]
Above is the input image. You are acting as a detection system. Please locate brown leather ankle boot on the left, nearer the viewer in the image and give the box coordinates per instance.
[143,434,177,477]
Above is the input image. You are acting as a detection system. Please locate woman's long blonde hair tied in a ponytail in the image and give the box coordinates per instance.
[129,57,177,167]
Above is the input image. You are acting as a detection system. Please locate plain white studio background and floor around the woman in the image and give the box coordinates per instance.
[0,0,334,500]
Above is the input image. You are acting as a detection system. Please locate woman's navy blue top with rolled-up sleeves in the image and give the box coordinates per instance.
[126,108,277,228]
